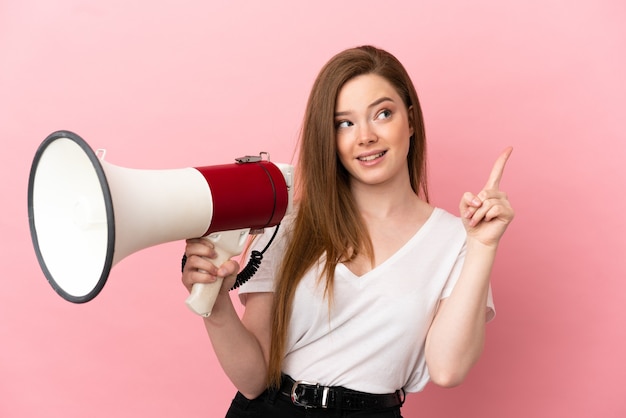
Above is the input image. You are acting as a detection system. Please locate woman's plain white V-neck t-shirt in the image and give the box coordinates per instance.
[239,208,495,393]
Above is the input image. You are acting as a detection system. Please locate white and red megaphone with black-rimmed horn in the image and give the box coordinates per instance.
[28,131,293,316]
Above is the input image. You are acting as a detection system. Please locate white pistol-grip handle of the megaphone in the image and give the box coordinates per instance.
[185,229,249,318]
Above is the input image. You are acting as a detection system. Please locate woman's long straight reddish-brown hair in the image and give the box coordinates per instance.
[268,46,428,387]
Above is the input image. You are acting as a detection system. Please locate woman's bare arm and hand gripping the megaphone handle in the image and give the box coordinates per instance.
[183,239,273,399]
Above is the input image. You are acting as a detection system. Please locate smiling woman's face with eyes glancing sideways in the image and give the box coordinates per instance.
[335,74,413,185]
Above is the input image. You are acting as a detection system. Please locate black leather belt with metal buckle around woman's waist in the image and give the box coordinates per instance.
[280,375,405,411]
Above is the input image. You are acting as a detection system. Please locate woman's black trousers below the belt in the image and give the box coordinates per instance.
[226,390,402,418]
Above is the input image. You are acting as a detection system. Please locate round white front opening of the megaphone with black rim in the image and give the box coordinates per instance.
[28,131,115,303]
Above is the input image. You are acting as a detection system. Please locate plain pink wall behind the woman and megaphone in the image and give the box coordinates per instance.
[0,0,626,418]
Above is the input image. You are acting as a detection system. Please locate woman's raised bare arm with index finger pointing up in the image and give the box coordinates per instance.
[426,148,514,387]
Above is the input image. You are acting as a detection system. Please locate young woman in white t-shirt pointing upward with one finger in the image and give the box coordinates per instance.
[182,46,513,418]
